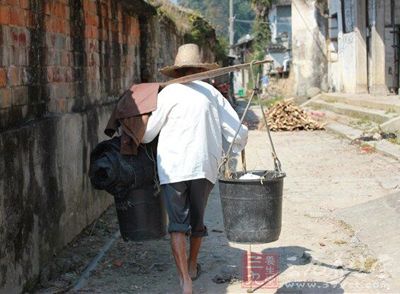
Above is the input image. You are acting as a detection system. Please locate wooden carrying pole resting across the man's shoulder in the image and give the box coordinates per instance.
[160,59,272,87]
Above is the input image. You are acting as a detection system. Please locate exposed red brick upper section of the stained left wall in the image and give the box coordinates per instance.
[0,0,145,129]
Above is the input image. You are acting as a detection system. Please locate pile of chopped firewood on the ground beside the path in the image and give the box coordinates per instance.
[266,99,324,131]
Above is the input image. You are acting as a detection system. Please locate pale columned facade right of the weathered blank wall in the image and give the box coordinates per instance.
[329,0,398,95]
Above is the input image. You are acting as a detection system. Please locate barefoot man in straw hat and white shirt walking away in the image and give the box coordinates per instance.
[143,44,248,294]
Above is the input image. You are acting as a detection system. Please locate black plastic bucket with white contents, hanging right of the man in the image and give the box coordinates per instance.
[219,170,285,243]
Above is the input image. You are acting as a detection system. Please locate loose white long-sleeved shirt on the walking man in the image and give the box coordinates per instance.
[142,81,248,184]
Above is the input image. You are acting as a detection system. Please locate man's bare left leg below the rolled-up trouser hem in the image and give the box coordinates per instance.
[171,233,192,294]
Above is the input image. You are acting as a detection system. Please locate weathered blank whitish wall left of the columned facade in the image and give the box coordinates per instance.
[292,0,328,96]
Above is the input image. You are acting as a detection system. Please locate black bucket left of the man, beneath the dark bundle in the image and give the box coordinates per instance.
[114,185,167,241]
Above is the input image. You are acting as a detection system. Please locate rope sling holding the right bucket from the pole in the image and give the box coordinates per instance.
[218,60,282,174]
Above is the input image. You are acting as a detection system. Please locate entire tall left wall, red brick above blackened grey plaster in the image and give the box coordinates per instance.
[0,0,213,293]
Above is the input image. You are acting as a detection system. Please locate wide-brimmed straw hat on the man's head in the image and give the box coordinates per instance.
[160,44,219,78]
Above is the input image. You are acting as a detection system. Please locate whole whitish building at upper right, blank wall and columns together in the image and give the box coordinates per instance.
[292,0,400,95]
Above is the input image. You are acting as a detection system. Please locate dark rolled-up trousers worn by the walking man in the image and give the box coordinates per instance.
[161,179,214,237]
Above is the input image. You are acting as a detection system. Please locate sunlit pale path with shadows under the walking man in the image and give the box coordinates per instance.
[36,131,400,293]
